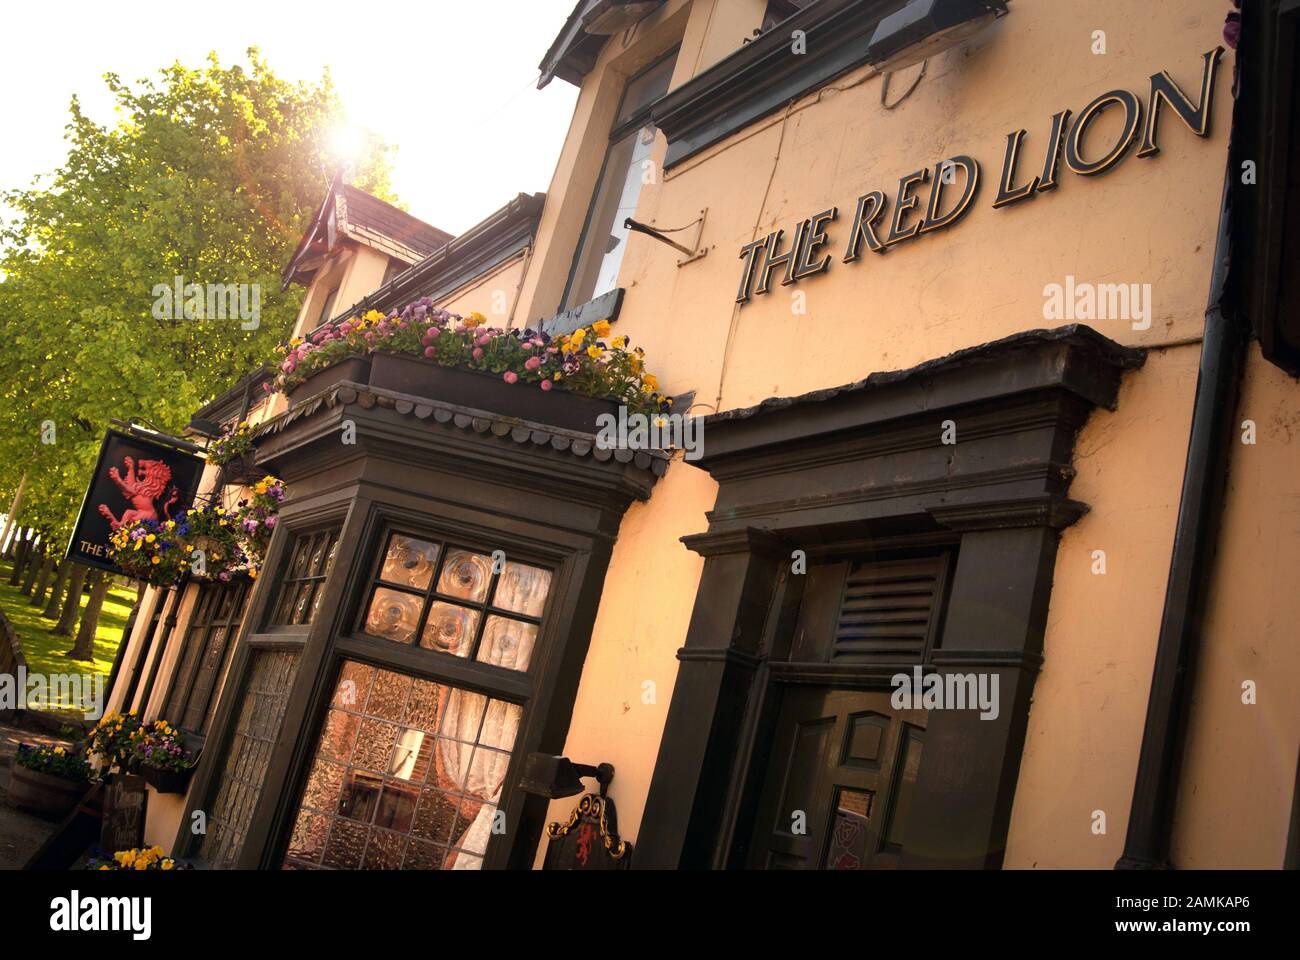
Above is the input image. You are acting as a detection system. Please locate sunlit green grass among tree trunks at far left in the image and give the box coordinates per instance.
[0,562,135,709]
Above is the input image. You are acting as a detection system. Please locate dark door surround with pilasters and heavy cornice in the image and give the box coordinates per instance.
[634,327,1143,868]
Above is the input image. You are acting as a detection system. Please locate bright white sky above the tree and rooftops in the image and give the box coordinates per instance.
[0,0,577,234]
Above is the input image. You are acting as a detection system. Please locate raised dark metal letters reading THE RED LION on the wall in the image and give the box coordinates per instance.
[736,47,1223,303]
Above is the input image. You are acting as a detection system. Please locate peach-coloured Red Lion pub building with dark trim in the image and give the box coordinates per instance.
[101,0,1300,869]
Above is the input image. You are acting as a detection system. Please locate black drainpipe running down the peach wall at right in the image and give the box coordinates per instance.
[1115,171,1245,870]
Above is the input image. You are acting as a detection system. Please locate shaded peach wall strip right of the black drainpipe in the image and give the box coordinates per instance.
[1171,346,1300,868]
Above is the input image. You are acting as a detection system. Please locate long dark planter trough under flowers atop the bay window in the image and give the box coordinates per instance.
[361,353,619,433]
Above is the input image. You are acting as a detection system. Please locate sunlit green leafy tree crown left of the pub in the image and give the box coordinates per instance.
[0,51,391,540]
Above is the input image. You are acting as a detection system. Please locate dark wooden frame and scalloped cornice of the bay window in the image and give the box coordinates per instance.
[182,390,662,869]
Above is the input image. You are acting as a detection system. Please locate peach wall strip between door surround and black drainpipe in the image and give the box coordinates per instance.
[1004,345,1200,869]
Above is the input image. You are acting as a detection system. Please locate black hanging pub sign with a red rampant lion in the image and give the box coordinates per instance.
[68,431,204,574]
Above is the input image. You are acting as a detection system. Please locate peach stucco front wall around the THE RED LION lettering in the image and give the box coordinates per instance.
[524,0,1279,868]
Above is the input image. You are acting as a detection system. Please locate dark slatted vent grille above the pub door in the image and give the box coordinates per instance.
[832,555,948,657]
